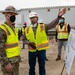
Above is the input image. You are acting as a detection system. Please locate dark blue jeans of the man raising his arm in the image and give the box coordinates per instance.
[29,50,46,75]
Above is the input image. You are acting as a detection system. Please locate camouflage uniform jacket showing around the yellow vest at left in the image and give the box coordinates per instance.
[0,23,20,65]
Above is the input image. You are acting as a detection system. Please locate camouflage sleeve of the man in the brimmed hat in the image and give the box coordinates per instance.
[0,28,9,64]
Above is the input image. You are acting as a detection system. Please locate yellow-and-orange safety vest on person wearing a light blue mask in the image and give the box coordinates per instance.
[56,23,69,39]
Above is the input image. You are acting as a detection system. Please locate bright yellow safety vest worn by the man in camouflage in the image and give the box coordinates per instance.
[0,24,20,58]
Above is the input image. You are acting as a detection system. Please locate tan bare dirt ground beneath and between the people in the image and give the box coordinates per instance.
[0,41,75,75]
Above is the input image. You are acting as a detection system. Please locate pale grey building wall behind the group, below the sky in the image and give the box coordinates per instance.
[0,7,75,30]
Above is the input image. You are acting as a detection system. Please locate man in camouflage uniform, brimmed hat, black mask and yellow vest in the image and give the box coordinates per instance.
[0,6,20,75]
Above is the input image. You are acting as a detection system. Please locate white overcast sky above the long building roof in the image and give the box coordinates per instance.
[0,0,75,10]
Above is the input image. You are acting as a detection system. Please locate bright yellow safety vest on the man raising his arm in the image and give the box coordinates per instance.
[25,24,49,52]
